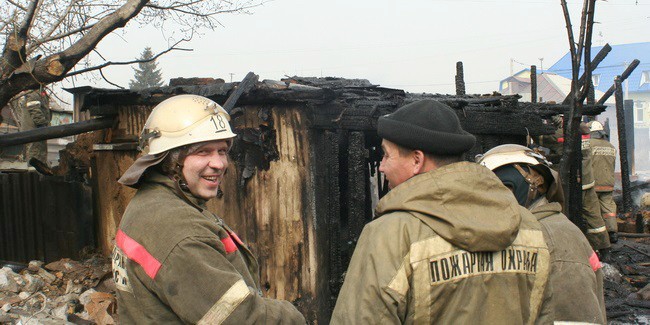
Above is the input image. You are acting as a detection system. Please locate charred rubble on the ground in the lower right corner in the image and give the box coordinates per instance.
[603,238,650,324]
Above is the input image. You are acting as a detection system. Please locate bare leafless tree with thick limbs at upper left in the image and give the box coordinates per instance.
[0,0,267,106]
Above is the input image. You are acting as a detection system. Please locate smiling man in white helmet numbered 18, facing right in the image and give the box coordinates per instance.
[113,95,305,324]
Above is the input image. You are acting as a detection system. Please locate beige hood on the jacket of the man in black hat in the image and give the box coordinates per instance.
[376,162,525,252]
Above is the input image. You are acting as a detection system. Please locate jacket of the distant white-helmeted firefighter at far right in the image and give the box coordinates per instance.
[590,139,616,192]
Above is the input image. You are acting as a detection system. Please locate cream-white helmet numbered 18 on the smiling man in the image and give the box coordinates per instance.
[140,95,236,155]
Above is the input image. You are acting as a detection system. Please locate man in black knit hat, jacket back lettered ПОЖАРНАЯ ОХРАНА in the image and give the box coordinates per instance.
[332,100,553,324]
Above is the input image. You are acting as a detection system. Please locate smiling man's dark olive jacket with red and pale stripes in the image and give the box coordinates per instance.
[113,171,305,324]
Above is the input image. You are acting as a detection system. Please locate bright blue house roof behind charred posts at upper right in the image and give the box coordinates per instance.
[548,42,650,92]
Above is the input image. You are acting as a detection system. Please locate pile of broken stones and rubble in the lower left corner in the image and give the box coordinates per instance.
[0,256,117,325]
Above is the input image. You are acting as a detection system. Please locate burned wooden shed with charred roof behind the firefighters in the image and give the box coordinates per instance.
[66,78,588,323]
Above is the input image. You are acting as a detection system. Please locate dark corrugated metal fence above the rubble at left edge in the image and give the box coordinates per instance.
[0,172,95,262]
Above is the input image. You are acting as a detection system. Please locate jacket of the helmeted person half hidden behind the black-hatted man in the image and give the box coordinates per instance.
[531,197,607,324]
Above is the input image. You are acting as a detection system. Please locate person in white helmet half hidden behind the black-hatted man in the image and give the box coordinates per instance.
[477,144,607,324]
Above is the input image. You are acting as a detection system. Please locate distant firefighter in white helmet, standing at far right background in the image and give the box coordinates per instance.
[589,121,618,243]
